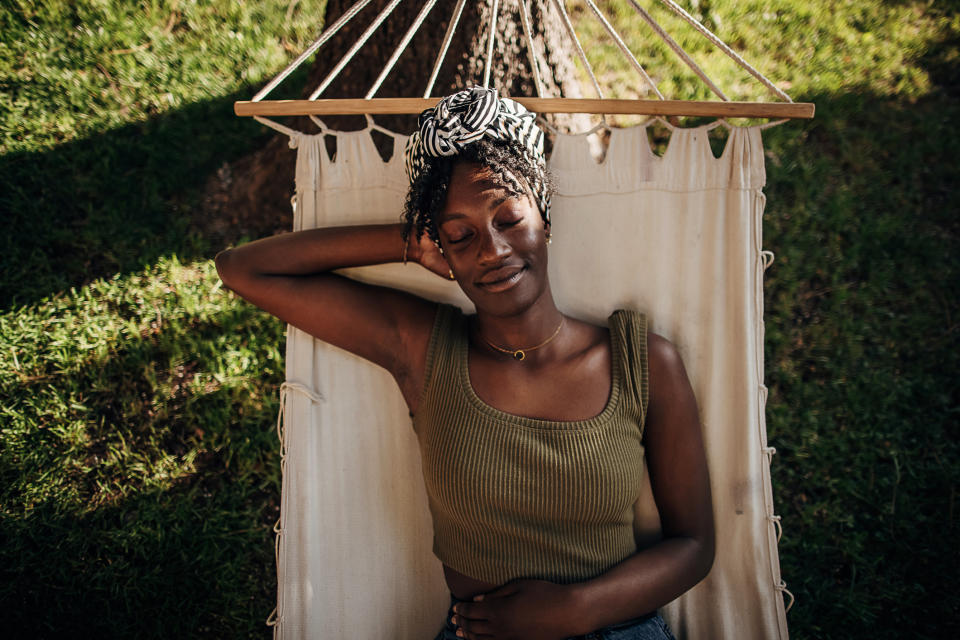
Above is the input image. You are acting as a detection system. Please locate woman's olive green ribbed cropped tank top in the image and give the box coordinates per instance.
[413,305,647,584]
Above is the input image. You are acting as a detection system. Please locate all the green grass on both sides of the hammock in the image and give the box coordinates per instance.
[0,0,960,639]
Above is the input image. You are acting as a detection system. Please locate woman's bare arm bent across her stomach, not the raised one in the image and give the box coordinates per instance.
[457,334,714,638]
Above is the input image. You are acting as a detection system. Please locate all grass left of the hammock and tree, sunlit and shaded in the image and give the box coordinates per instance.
[0,0,324,638]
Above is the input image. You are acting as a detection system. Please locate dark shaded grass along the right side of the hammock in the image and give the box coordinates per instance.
[752,87,960,639]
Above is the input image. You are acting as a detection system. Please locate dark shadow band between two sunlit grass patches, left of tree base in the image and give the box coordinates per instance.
[0,88,293,309]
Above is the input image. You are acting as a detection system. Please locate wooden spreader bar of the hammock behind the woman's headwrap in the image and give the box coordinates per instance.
[233,96,814,119]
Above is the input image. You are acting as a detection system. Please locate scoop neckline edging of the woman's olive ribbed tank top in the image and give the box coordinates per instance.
[457,316,623,431]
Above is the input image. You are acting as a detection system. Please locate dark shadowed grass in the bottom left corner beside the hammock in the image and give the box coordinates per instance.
[0,478,276,639]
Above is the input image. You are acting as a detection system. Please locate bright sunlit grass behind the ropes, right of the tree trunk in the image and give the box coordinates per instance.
[571,0,957,123]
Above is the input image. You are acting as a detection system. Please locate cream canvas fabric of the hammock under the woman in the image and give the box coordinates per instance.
[266,122,787,640]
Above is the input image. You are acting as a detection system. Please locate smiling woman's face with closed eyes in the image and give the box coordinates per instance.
[437,162,549,316]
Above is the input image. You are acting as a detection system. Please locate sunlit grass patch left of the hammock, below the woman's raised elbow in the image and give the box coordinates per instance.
[0,259,282,515]
